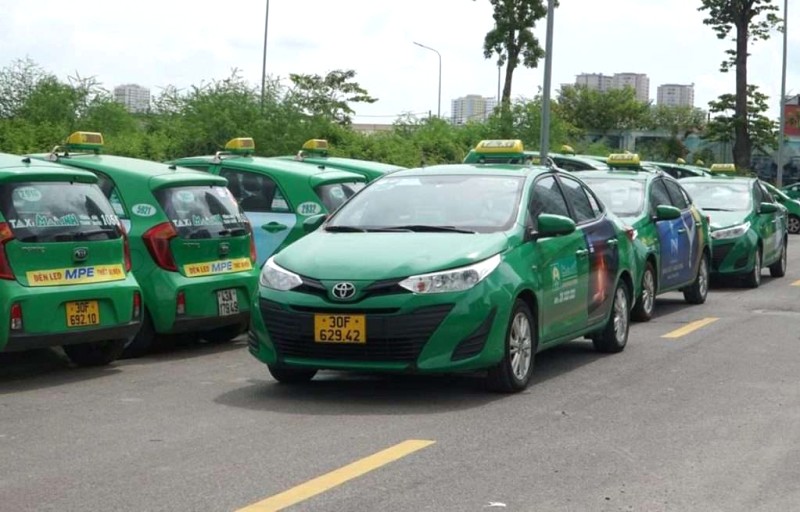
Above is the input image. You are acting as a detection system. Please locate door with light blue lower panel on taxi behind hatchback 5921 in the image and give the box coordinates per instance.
[219,168,297,266]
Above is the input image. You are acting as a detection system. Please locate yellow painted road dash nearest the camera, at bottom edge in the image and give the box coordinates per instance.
[236,439,436,512]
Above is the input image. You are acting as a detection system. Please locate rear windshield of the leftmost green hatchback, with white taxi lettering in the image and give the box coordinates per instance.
[0,181,121,242]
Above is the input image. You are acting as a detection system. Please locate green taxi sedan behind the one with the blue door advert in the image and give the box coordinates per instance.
[681,164,788,288]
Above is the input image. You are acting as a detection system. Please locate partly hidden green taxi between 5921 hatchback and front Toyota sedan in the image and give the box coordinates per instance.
[172,137,366,266]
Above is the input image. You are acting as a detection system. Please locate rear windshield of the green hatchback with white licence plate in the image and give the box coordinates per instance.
[155,185,247,238]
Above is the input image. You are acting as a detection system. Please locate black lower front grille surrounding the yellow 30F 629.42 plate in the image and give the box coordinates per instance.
[260,299,453,363]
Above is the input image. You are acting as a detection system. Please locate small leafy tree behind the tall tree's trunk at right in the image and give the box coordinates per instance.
[703,85,778,159]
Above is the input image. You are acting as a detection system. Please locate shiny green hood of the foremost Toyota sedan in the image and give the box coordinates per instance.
[275,230,509,281]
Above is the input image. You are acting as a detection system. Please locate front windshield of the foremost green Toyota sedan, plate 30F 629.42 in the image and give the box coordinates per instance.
[326,175,525,233]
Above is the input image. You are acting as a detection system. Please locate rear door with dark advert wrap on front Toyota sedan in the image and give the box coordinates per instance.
[559,175,619,324]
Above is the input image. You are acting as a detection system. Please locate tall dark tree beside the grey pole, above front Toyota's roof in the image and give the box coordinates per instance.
[476,0,547,111]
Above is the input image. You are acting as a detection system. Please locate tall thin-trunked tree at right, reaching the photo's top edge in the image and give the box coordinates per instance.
[699,0,780,169]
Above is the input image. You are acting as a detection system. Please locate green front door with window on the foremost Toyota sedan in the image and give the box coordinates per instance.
[529,174,589,345]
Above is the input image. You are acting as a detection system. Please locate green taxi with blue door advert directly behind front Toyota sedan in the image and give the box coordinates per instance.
[580,153,711,321]
